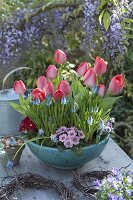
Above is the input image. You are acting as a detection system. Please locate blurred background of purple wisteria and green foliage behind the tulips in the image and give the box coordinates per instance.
[0,0,133,158]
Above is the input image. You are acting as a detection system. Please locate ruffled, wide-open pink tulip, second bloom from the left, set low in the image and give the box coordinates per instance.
[31,88,46,102]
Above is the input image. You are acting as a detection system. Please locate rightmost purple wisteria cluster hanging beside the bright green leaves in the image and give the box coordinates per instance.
[100,0,133,60]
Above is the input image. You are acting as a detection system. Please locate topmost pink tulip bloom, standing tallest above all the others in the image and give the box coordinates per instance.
[54,49,66,64]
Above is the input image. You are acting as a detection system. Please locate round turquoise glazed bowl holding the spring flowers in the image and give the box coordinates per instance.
[28,137,109,170]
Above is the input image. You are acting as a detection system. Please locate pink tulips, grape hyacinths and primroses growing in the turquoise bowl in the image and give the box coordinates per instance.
[11,49,124,148]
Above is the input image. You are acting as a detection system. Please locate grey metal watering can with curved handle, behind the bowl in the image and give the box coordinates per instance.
[0,67,31,137]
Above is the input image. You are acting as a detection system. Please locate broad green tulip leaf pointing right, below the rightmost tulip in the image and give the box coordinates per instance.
[101,96,122,110]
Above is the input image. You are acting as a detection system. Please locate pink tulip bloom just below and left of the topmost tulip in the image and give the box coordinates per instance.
[46,65,58,79]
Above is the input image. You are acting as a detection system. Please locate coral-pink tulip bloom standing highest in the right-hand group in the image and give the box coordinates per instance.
[94,56,107,75]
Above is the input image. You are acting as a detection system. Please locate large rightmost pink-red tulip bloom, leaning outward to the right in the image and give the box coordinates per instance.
[109,74,124,95]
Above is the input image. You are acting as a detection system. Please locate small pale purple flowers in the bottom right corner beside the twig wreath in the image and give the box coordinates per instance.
[95,168,133,200]
